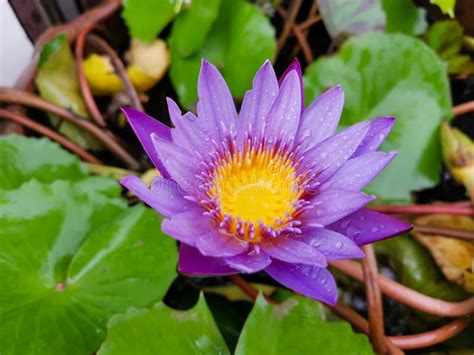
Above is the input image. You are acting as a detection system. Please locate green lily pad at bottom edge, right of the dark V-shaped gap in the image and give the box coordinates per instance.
[235,295,373,355]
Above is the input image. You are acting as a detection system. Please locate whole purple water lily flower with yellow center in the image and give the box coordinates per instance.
[122,61,410,304]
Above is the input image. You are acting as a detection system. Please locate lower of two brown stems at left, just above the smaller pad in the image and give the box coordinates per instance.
[0,109,102,164]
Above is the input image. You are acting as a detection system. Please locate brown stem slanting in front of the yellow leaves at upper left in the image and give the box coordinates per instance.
[87,34,144,111]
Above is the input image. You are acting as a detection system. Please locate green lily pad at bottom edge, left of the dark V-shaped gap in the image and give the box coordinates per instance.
[99,294,229,355]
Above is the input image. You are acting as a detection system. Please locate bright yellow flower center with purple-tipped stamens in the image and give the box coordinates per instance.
[207,144,303,243]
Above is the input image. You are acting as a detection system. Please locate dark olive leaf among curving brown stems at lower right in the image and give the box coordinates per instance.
[374,235,467,301]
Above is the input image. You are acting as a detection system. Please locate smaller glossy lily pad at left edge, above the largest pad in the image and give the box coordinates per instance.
[0,134,87,190]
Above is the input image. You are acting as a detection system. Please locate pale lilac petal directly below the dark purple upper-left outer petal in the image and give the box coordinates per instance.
[151,133,198,191]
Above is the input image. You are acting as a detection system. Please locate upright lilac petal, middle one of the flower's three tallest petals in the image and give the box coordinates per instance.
[237,60,279,145]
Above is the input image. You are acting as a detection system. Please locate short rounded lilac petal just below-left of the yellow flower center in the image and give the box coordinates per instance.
[196,230,248,257]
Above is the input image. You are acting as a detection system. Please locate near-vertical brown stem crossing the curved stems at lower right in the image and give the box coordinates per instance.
[362,245,385,354]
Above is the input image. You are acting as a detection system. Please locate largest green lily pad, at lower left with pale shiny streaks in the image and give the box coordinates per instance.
[0,181,177,355]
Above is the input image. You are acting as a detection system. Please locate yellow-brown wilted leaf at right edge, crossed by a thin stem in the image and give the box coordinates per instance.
[412,215,474,293]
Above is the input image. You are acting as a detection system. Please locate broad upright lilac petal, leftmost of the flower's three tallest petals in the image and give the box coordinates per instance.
[197,60,237,142]
